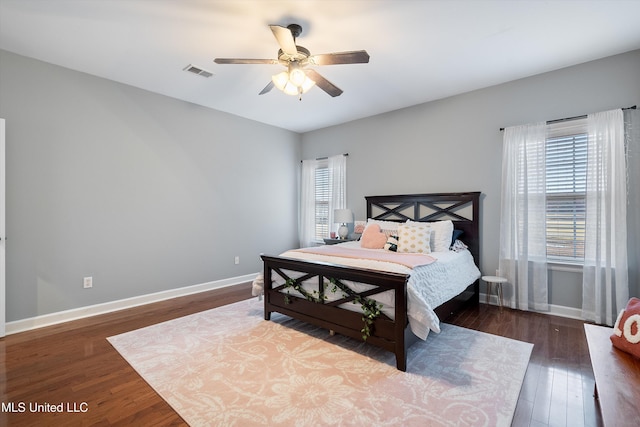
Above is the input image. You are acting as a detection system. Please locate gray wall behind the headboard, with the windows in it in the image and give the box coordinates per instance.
[302,50,640,308]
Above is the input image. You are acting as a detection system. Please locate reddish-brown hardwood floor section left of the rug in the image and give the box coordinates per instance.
[0,284,251,427]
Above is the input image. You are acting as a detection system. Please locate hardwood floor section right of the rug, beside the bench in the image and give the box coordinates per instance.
[447,304,602,427]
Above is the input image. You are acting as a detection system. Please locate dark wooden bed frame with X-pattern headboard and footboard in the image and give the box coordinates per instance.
[262,192,480,371]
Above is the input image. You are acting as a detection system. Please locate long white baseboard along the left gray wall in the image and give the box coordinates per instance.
[5,273,258,335]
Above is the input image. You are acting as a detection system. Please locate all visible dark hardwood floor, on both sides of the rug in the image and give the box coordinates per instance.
[0,284,601,427]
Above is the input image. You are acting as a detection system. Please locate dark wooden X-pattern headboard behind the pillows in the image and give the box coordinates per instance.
[365,191,480,266]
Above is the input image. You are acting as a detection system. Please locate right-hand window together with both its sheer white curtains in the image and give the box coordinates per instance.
[499,109,629,318]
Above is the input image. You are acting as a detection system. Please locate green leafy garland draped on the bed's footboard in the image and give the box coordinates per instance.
[284,278,382,341]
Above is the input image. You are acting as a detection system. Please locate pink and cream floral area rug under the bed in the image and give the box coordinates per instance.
[108,299,533,426]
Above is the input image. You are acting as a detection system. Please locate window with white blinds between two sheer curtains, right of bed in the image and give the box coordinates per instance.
[545,119,588,262]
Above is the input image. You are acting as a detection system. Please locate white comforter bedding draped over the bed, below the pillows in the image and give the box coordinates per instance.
[258,241,480,340]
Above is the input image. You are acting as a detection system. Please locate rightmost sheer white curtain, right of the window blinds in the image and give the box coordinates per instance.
[582,110,637,325]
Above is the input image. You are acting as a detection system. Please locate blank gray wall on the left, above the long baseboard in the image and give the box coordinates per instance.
[0,51,301,321]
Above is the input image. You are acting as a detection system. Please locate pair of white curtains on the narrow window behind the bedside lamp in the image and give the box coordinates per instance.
[298,154,347,247]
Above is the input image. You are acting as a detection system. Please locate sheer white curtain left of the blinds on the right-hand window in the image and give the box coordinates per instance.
[499,122,548,311]
